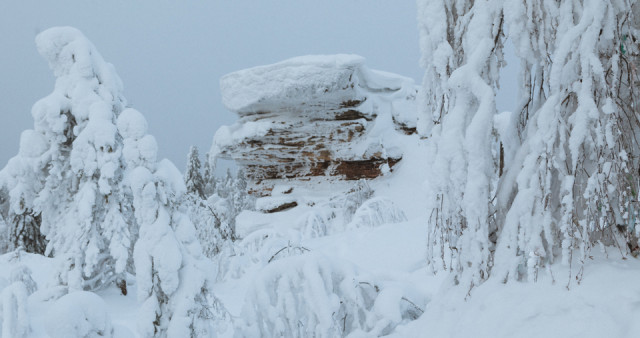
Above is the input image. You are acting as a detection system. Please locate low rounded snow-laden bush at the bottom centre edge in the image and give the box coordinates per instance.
[236,253,422,337]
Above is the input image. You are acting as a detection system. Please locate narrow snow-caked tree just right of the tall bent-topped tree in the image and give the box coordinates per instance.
[118,109,219,337]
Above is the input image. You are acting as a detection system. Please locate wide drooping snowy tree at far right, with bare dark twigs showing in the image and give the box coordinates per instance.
[495,0,640,280]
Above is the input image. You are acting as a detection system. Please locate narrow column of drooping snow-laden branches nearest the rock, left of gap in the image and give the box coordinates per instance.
[418,0,503,287]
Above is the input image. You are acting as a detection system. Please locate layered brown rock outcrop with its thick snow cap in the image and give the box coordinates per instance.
[211,55,417,186]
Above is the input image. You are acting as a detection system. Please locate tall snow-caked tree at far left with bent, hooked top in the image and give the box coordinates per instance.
[2,27,134,289]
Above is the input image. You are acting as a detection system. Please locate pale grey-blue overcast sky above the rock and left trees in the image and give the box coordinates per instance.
[0,0,516,170]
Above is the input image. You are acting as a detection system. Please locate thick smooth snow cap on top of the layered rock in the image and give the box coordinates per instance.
[220,54,413,115]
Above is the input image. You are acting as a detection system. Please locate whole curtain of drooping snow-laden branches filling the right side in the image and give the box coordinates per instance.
[418,0,640,285]
